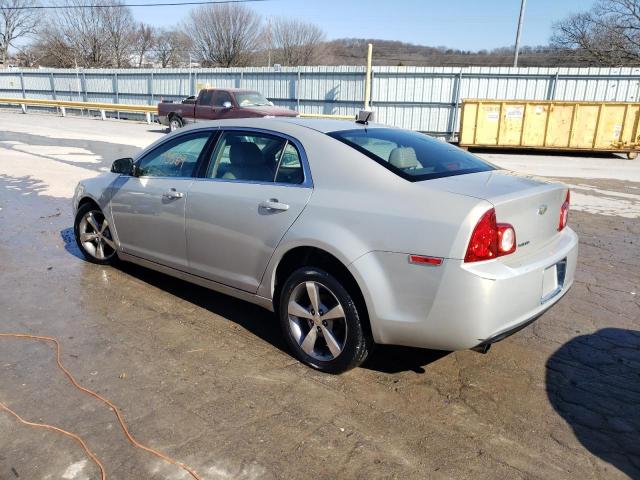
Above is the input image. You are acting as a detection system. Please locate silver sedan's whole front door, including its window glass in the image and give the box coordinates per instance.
[111,131,211,270]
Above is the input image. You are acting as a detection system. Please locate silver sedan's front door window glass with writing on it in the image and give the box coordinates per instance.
[137,132,210,177]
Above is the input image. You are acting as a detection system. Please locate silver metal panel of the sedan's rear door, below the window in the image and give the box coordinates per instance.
[186,179,312,293]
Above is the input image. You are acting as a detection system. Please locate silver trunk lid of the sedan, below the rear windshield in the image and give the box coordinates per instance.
[421,170,567,258]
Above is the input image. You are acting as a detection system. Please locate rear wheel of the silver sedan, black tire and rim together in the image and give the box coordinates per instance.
[279,267,372,373]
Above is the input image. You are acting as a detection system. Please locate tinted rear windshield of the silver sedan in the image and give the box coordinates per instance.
[328,128,495,182]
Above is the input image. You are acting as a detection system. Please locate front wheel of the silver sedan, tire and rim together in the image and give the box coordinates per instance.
[73,203,116,265]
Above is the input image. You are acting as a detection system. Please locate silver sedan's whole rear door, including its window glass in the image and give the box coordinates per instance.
[186,130,312,293]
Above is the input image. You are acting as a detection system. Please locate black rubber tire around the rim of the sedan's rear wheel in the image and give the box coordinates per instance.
[279,266,373,374]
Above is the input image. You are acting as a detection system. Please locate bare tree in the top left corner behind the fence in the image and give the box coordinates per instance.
[0,0,38,65]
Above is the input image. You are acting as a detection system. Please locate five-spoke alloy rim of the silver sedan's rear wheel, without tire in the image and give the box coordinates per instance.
[287,281,347,361]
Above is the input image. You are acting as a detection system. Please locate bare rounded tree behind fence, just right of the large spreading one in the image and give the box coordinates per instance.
[270,17,325,65]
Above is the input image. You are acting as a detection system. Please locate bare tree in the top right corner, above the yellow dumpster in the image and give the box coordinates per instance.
[551,0,640,66]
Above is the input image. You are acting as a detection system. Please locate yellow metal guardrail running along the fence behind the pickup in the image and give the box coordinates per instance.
[0,97,355,123]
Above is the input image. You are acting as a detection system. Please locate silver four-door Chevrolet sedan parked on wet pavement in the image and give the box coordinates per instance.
[73,118,578,373]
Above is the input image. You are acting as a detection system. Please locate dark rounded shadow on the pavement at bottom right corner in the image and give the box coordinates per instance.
[546,328,640,478]
